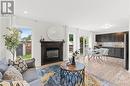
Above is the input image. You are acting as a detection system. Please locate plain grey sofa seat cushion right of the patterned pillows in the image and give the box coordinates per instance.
[23,68,38,82]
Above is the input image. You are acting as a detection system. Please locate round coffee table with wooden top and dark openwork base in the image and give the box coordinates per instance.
[60,62,85,86]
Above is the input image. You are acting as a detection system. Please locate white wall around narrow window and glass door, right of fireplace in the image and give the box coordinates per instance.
[67,27,94,57]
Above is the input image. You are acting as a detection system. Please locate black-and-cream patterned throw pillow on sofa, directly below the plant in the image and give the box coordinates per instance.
[9,58,28,73]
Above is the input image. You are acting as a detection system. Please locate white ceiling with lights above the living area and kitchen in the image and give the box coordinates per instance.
[15,0,129,31]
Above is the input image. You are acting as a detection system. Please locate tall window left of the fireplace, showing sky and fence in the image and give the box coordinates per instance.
[16,28,32,60]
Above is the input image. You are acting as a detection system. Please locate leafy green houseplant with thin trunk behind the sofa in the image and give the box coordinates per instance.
[3,27,20,60]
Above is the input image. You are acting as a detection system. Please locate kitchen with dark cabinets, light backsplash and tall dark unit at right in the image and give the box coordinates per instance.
[95,32,129,70]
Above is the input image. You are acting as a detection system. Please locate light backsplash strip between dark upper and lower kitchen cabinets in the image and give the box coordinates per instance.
[96,42,125,48]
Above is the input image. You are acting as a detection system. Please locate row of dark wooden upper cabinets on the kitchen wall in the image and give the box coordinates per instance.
[96,33,124,42]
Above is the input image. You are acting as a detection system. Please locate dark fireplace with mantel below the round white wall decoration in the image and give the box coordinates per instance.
[40,40,64,65]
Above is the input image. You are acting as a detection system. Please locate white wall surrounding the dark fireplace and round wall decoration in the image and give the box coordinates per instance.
[13,16,66,66]
